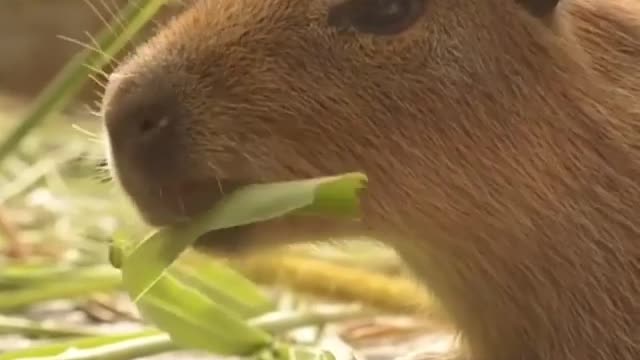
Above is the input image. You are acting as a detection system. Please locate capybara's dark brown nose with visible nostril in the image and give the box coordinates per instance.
[103,77,185,180]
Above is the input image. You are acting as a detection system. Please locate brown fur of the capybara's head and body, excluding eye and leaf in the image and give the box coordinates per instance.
[104,0,640,360]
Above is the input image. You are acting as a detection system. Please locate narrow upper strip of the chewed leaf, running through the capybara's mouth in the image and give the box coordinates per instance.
[122,173,366,302]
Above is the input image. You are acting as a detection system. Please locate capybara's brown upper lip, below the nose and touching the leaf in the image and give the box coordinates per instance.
[127,179,249,226]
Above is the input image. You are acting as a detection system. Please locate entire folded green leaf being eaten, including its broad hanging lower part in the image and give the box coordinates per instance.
[117,173,366,355]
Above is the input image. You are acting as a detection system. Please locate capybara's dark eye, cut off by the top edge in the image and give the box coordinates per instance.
[327,0,426,35]
